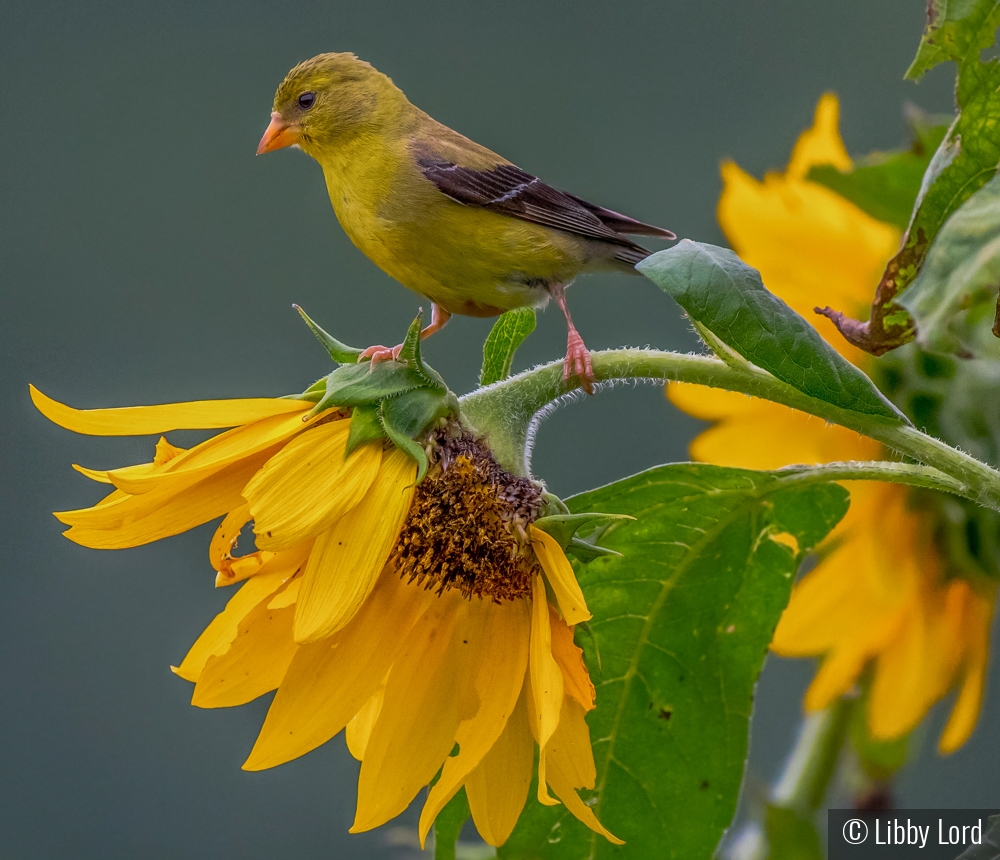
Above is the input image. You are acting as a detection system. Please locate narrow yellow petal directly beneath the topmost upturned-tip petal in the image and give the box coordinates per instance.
[108,413,319,495]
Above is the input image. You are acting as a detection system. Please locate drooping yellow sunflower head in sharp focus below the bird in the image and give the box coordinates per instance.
[31,388,621,845]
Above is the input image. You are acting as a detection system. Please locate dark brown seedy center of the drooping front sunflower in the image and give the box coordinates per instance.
[393,431,543,603]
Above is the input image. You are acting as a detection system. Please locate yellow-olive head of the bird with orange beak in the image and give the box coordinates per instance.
[257,54,409,158]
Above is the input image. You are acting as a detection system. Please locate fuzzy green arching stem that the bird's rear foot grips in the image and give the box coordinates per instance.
[461,349,1000,510]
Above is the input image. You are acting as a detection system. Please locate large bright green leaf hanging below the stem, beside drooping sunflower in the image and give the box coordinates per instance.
[498,464,848,860]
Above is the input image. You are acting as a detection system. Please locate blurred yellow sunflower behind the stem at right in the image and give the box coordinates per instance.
[668,94,996,753]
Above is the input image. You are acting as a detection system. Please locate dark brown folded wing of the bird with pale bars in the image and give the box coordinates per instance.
[417,155,677,265]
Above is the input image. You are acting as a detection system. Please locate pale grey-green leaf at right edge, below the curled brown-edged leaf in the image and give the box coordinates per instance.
[900,177,1000,358]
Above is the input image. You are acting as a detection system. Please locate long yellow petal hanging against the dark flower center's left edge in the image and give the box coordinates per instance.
[295,446,417,643]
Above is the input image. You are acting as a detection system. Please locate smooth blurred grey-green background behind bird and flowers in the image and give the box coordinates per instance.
[0,0,1000,858]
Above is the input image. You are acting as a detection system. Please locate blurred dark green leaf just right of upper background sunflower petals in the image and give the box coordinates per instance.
[806,117,951,230]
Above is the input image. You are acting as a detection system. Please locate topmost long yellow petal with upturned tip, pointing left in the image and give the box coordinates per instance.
[28,385,312,436]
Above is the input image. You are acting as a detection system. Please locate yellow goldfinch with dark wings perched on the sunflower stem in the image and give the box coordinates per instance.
[257,53,676,391]
